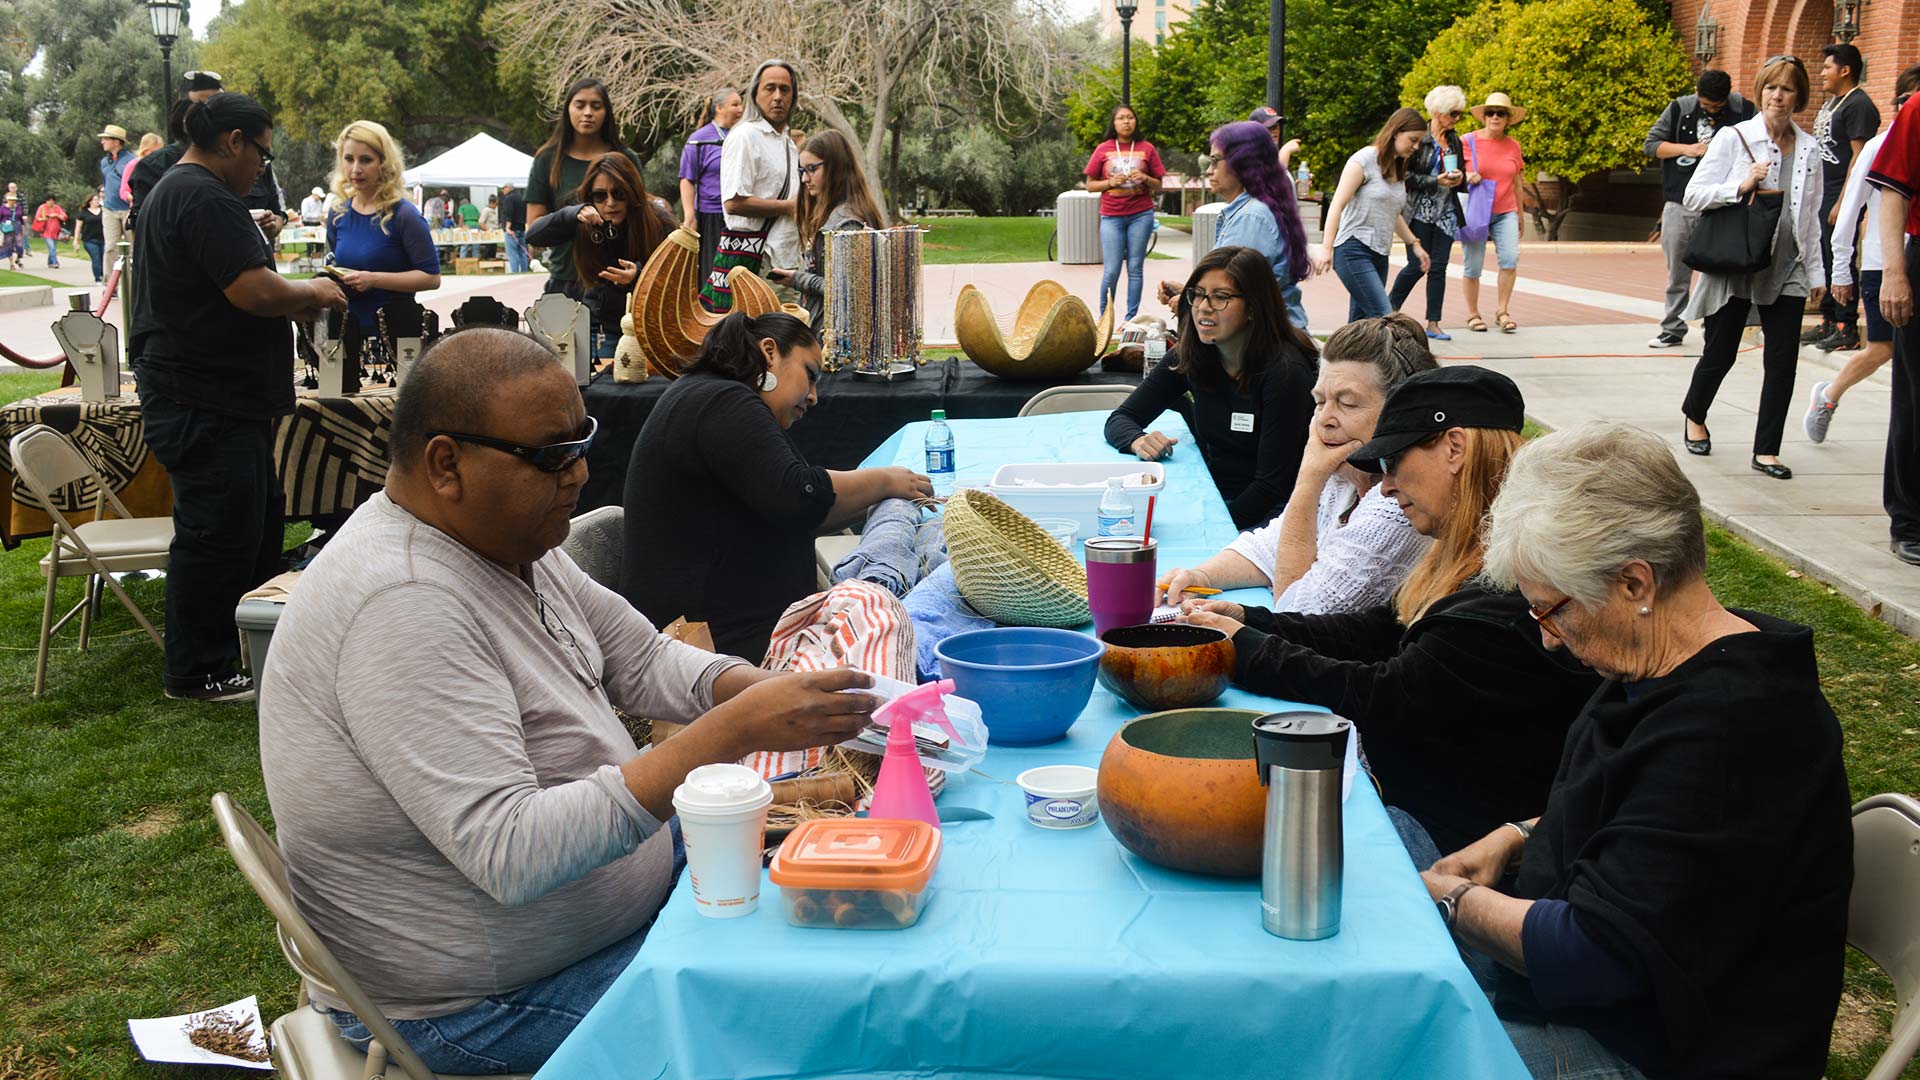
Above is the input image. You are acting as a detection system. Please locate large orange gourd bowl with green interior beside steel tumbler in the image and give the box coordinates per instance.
[1100,709,1267,878]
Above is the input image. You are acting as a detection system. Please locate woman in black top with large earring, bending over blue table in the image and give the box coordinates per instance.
[622,311,933,663]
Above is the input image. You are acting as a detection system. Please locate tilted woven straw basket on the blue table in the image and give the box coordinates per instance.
[947,488,1092,628]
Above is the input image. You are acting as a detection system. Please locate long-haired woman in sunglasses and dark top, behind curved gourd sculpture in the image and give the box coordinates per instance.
[526,152,680,357]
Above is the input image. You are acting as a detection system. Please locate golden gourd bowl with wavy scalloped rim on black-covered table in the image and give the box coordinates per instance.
[954,281,1114,382]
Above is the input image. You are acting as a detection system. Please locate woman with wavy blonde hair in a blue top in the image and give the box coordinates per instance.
[326,119,440,334]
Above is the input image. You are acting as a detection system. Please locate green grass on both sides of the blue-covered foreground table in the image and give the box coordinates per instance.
[0,367,1920,1080]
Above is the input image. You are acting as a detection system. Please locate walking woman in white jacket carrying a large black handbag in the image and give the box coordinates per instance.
[1680,56,1826,480]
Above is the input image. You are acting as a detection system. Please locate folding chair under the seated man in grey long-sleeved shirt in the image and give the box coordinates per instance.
[213,792,526,1080]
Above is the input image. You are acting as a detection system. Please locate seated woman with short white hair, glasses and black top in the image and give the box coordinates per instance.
[1428,418,1853,1078]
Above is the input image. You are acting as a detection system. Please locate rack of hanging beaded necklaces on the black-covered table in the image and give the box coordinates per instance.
[820,225,925,379]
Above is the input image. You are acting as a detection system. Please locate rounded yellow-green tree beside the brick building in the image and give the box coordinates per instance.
[1402,0,1692,240]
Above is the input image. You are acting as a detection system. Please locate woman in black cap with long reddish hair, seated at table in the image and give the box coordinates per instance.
[1183,365,1599,853]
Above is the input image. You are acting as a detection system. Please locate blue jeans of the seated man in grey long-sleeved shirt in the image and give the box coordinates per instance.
[330,817,687,1076]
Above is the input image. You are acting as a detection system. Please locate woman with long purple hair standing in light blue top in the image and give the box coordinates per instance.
[1160,121,1313,331]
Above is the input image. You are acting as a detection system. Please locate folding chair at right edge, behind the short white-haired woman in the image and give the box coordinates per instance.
[1847,794,1920,1080]
